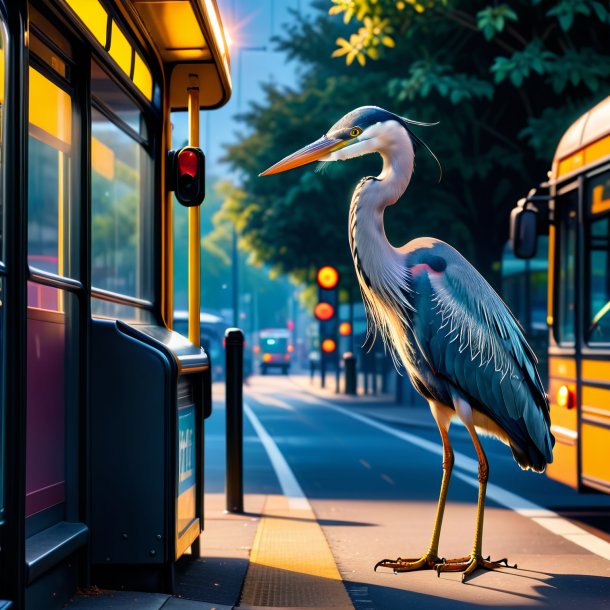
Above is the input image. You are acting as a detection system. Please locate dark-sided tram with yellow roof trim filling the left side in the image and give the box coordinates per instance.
[0,0,231,610]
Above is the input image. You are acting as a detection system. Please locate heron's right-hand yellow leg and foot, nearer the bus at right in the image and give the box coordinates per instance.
[435,416,517,582]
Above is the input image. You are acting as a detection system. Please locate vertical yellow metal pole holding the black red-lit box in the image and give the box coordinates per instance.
[188,74,201,347]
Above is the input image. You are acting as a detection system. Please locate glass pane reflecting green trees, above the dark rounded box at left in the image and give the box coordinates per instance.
[91,109,153,299]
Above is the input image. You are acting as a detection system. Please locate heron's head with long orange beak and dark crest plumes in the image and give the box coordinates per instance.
[260,106,440,176]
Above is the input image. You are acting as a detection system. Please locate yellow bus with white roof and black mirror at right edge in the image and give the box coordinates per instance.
[511,97,610,493]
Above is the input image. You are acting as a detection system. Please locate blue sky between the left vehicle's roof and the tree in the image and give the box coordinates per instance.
[173,0,314,177]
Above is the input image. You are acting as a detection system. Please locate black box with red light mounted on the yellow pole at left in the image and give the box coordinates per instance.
[166,146,205,207]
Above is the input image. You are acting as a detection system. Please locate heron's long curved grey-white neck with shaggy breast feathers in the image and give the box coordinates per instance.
[350,121,414,366]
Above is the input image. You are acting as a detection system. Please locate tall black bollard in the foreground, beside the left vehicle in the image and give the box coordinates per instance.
[225,328,244,513]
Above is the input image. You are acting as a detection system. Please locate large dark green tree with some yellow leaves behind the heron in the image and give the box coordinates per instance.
[227,0,610,285]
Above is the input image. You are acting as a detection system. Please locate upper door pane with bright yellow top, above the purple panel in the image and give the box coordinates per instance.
[28,68,78,277]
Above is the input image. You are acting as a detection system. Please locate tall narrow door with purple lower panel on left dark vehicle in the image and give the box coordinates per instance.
[25,9,87,607]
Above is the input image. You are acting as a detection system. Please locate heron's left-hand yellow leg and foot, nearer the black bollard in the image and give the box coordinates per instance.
[375,403,454,572]
